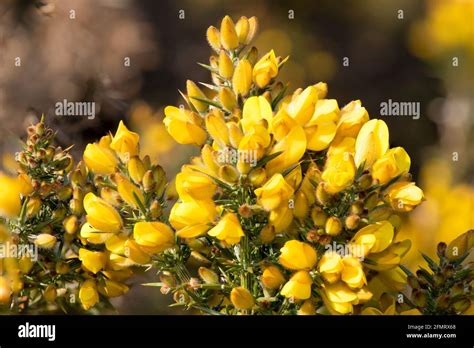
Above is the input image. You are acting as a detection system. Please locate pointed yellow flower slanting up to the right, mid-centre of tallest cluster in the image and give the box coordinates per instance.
[266,126,306,175]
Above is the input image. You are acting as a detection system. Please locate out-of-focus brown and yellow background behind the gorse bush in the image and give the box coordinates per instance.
[0,0,474,314]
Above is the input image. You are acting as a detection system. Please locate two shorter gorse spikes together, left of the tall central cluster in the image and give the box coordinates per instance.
[0,119,169,312]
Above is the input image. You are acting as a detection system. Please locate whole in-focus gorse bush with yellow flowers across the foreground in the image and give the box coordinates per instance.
[0,16,473,315]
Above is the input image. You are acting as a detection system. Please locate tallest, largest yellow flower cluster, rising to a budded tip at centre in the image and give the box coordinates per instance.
[154,16,423,314]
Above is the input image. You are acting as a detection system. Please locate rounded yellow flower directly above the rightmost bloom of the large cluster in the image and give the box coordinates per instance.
[372,147,411,184]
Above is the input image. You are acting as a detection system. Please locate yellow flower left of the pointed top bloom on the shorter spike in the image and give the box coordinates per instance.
[84,143,118,175]
